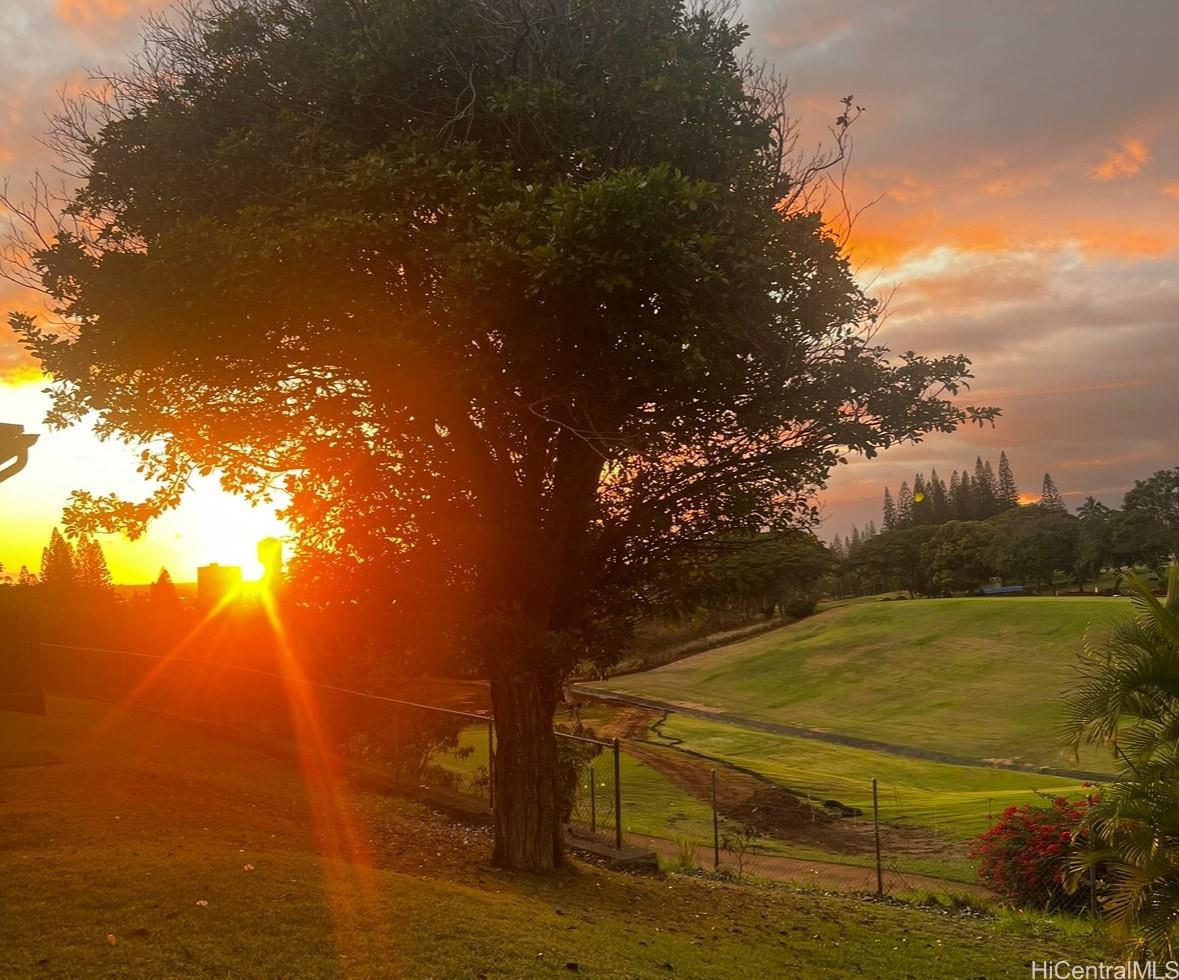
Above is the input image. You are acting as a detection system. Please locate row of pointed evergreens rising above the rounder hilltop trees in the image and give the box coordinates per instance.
[831,450,1067,558]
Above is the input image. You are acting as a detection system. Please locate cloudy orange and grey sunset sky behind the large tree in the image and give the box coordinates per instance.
[0,0,1179,581]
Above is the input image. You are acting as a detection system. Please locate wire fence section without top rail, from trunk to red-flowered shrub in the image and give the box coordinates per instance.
[621,735,1103,910]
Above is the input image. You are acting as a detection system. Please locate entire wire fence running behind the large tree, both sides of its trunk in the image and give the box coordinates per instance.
[41,643,1027,893]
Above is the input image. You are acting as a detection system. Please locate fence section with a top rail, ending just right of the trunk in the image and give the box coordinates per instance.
[40,643,624,849]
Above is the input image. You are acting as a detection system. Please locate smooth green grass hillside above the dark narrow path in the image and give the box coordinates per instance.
[600,598,1129,771]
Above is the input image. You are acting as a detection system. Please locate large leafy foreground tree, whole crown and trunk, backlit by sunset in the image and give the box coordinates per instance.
[6,0,993,868]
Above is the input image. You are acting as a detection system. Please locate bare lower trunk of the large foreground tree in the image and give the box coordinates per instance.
[492,672,565,870]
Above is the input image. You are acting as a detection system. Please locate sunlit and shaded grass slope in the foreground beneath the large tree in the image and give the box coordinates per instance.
[0,699,1102,978]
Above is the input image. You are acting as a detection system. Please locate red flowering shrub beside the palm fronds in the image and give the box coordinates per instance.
[970,796,1096,910]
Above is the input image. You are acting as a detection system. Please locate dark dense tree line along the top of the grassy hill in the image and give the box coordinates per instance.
[831,467,1179,596]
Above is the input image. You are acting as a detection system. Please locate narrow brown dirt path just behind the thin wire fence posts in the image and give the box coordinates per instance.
[627,834,994,899]
